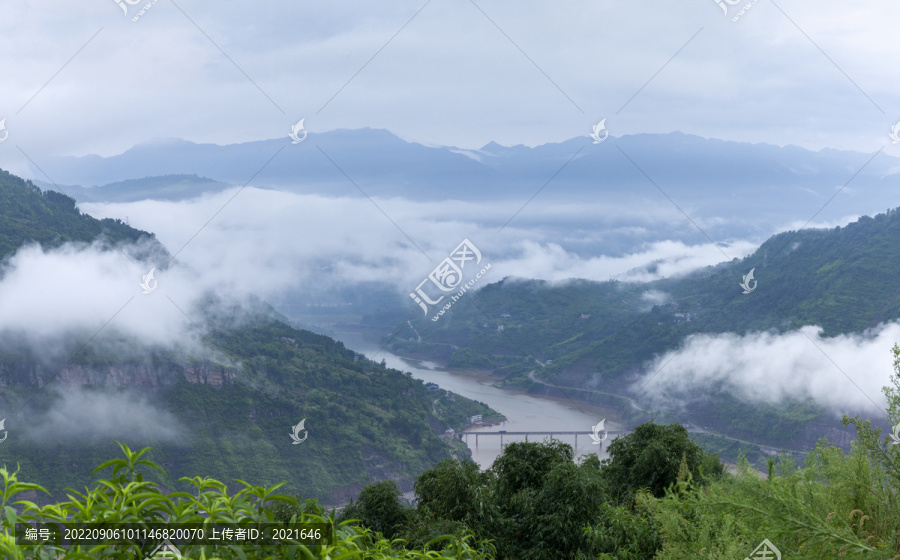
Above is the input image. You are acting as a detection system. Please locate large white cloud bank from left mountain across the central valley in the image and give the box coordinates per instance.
[0,188,754,357]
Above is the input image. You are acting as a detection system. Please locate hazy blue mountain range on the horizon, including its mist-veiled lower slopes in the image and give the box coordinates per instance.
[33,128,900,247]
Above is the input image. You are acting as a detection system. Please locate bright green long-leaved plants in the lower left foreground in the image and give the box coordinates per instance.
[0,443,488,560]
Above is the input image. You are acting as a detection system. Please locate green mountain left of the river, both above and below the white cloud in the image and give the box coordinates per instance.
[0,173,496,503]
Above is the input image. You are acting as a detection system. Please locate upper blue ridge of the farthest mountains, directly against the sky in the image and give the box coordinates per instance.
[28,128,900,198]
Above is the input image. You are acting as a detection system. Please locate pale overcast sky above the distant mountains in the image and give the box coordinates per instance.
[0,0,900,163]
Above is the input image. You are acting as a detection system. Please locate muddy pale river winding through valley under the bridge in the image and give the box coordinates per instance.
[336,332,624,469]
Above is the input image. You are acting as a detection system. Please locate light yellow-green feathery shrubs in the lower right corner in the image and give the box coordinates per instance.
[649,444,900,560]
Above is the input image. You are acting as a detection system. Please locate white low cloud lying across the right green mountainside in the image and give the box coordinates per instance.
[632,323,900,415]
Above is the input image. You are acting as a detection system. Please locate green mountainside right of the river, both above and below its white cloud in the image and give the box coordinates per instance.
[390,210,900,456]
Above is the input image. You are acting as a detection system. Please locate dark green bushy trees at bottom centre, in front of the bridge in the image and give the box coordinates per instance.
[340,423,723,560]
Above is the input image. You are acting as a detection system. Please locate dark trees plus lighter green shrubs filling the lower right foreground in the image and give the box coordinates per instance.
[326,412,900,560]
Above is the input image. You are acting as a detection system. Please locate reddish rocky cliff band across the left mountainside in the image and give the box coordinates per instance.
[0,362,238,389]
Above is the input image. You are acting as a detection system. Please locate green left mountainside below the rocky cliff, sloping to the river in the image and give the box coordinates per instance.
[0,314,492,503]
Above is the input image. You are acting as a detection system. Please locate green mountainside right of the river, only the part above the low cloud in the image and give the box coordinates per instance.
[392,210,900,378]
